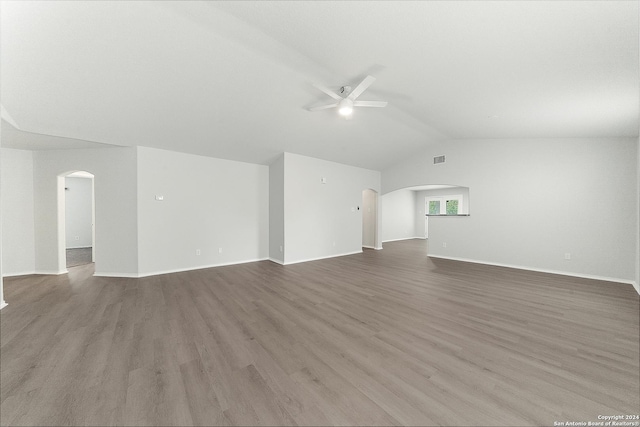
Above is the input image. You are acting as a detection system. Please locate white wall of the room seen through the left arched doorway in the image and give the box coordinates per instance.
[64,177,93,249]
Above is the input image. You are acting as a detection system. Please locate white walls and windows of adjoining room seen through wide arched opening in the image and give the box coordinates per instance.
[382,184,470,242]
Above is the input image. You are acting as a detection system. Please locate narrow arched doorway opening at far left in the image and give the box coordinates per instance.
[58,171,96,271]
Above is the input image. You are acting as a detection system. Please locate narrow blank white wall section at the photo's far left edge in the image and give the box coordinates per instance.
[0,148,35,276]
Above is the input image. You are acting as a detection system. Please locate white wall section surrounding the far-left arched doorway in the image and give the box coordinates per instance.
[31,147,138,276]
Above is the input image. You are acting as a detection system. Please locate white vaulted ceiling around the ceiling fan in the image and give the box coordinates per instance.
[0,1,640,170]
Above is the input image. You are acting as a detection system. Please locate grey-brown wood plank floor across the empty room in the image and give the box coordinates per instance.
[0,240,640,426]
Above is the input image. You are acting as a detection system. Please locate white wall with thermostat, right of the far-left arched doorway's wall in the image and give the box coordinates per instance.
[136,147,269,276]
